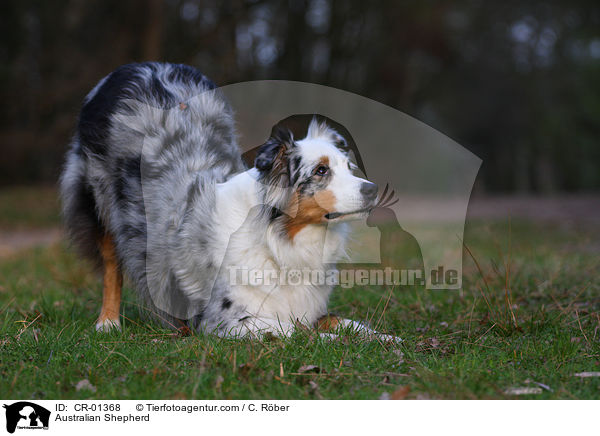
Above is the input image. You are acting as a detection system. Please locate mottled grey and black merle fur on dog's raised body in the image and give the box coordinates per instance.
[60,63,245,324]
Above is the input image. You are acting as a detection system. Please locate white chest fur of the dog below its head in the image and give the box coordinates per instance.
[203,169,346,334]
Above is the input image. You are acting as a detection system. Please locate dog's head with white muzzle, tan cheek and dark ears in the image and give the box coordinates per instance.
[254,119,377,238]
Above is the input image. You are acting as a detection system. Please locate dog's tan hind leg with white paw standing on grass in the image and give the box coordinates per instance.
[96,233,123,332]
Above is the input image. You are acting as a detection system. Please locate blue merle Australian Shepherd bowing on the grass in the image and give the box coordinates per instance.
[60,62,396,340]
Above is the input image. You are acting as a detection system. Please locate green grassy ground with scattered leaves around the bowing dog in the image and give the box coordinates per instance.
[0,188,600,399]
